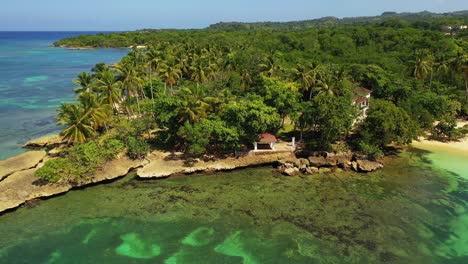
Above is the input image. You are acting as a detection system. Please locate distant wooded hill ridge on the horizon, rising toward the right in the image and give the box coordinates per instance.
[207,10,468,30]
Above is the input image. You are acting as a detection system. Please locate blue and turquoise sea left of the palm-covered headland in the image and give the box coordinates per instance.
[0,32,127,160]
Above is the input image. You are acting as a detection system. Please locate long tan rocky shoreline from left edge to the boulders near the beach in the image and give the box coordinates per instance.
[0,136,383,213]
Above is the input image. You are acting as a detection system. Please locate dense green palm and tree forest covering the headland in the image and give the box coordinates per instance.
[36,16,468,183]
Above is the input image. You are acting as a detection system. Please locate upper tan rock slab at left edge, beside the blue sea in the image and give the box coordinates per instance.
[0,150,46,181]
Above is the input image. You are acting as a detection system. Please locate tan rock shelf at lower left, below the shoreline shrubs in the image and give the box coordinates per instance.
[0,157,146,212]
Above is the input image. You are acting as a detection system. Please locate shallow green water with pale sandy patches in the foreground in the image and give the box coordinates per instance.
[0,150,468,264]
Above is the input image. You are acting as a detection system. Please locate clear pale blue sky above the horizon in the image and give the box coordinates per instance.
[0,0,468,30]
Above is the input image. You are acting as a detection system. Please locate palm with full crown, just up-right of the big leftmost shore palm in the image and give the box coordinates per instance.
[96,69,122,113]
